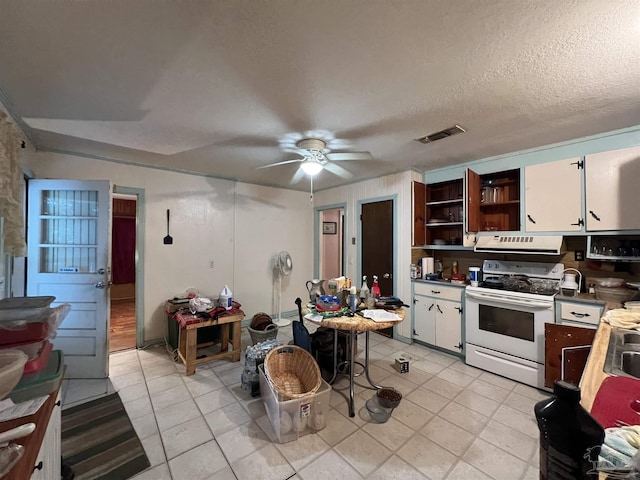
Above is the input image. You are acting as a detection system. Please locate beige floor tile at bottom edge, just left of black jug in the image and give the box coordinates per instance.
[462,438,528,480]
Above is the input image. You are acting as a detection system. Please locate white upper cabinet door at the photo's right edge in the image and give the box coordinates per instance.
[585,147,640,231]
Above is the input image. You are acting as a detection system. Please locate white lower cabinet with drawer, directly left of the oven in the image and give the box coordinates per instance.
[413,284,463,354]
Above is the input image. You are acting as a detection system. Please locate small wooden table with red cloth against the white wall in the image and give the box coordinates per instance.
[165,304,244,375]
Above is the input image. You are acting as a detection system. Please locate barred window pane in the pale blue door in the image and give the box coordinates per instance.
[40,190,98,273]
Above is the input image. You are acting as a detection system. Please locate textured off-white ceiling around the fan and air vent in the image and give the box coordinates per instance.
[0,0,640,190]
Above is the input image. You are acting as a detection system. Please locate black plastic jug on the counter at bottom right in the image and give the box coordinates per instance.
[533,380,604,480]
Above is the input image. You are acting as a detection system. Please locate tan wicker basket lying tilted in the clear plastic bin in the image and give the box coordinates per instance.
[264,345,322,401]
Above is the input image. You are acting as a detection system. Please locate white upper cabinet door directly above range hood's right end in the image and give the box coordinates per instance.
[524,158,583,232]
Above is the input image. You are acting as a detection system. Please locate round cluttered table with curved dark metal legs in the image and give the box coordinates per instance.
[304,308,404,417]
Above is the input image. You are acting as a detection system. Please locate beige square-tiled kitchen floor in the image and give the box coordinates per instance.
[63,329,547,480]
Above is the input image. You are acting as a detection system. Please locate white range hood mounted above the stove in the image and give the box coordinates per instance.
[473,234,564,255]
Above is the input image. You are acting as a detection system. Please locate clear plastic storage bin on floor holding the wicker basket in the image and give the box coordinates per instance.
[258,365,331,443]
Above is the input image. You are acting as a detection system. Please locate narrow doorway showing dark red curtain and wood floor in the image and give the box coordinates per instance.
[109,194,137,353]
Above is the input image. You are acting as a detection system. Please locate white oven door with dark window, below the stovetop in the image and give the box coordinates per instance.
[465,289,554,364]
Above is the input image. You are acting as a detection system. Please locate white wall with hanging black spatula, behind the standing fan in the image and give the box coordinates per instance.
[29,152,313,341]
